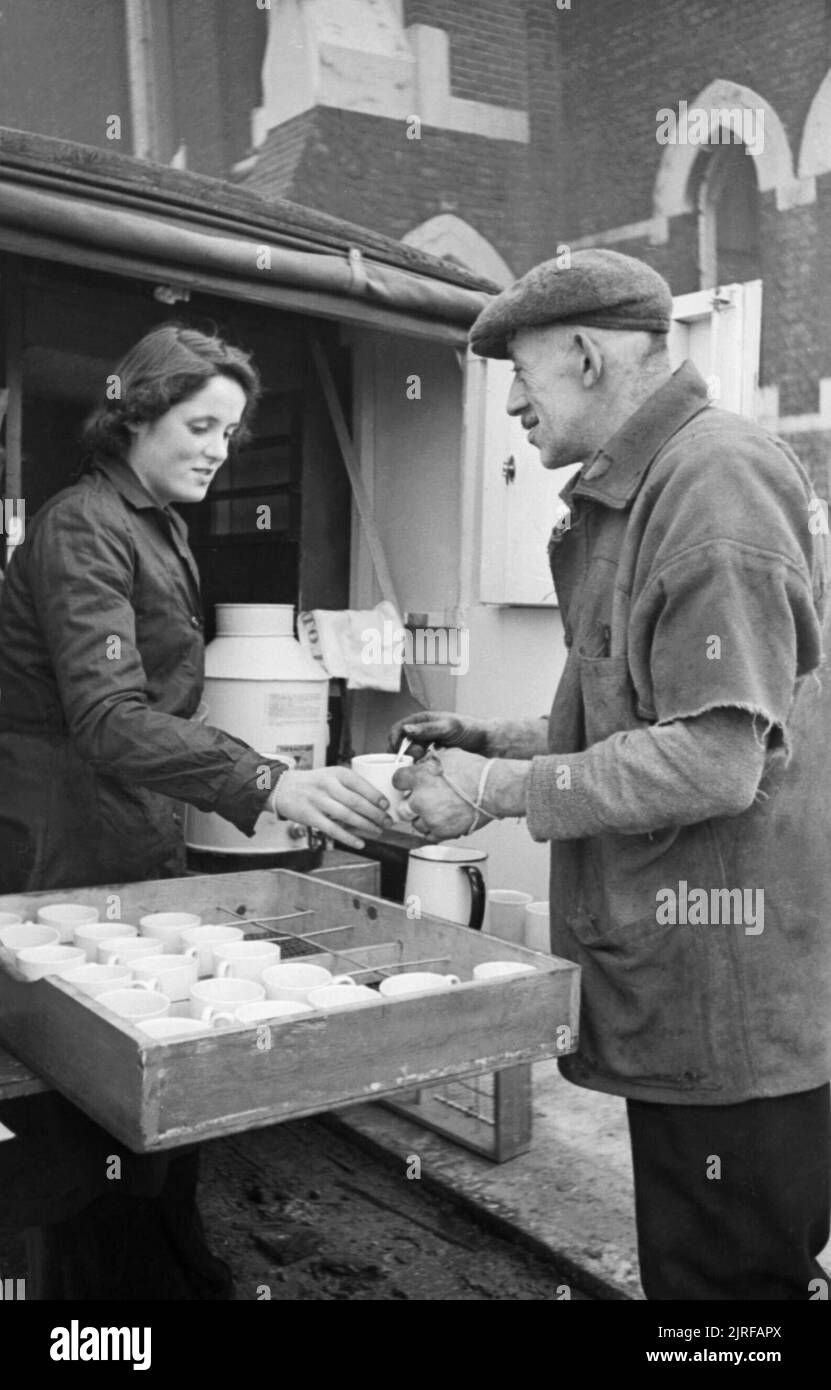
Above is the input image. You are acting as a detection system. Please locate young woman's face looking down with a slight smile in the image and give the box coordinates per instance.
[126,377,246,507]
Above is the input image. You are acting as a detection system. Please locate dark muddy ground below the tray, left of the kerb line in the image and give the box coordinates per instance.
[200,1120,585,1302]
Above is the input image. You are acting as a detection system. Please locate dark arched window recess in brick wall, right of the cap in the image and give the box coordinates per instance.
[698,145,762,289]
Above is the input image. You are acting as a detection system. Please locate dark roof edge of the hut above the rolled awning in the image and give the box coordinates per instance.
[0,126,500,293]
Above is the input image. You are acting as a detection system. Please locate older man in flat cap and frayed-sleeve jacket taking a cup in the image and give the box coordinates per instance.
[392,250,831,1300]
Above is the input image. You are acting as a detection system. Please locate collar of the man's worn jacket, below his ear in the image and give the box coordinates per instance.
[560,360,709,510]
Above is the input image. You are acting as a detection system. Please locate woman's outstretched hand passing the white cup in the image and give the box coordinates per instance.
[270,767,392,849]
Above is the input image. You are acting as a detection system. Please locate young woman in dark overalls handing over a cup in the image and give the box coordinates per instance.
[0,324,389,1298]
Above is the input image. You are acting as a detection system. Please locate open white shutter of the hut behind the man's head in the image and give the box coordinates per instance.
[478,281,762,607]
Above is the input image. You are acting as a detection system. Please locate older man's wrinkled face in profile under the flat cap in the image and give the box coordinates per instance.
[507,325,592,468]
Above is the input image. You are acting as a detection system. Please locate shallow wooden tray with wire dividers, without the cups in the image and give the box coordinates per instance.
[0,869,579,1152]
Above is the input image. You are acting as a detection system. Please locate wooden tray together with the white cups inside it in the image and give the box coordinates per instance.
[0,870,579,1152]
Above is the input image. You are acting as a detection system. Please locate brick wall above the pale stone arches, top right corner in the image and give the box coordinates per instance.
[552,0,831,236]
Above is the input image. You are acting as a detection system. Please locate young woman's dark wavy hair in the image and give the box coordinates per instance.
[81,324,260,471]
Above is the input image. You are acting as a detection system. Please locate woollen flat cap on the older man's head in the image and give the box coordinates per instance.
[470,249,673,357]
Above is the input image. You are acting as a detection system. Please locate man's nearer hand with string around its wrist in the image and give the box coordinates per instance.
[392,749,489,841]
